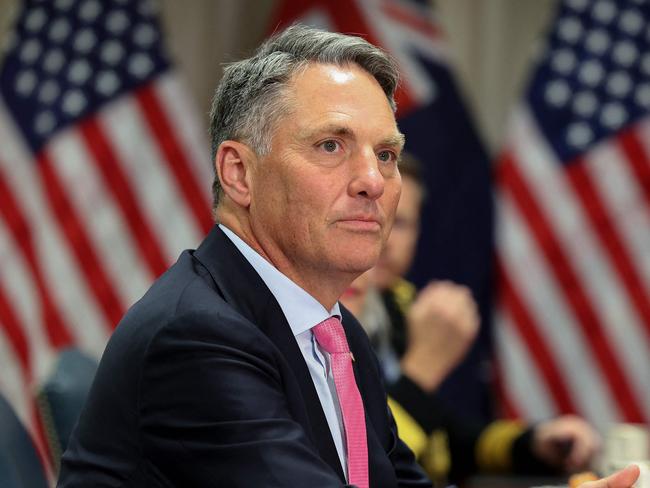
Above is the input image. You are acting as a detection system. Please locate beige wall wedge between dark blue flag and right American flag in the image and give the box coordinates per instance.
[434,0,557,151]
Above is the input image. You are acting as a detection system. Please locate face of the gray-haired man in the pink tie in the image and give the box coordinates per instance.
[250,64,403,285]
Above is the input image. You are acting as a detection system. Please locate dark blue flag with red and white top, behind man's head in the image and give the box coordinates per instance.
[271,0,492,417]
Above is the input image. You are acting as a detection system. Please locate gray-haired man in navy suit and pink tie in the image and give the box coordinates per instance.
[60,26,627,488]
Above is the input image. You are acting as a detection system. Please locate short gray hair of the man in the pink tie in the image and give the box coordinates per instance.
[210,24,399,208]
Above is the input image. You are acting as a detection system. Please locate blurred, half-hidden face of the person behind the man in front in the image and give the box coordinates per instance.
[374,176,422,290]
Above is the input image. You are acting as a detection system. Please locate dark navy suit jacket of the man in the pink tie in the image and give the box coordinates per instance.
[59,227,430,488]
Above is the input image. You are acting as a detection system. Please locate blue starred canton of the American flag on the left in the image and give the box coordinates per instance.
[0,0,169,152]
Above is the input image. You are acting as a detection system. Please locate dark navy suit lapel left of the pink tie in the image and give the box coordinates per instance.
[194,226,345,480]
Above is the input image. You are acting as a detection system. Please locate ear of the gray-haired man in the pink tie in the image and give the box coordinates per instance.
[215,141,255,208]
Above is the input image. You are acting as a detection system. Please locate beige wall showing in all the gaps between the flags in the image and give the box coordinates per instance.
[0,0,557,154]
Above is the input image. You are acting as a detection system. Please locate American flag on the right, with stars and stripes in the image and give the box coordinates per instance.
[495,0,650,430]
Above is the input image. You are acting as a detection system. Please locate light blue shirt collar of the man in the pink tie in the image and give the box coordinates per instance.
[219,224,341,336]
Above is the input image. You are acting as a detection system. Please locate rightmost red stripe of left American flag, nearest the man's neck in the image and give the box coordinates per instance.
[136,86,214,233]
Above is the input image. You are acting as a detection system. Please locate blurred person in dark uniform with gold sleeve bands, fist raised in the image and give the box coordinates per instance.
[341,154,600,484]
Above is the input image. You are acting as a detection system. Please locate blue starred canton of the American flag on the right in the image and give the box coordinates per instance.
[527,0,650,164]
